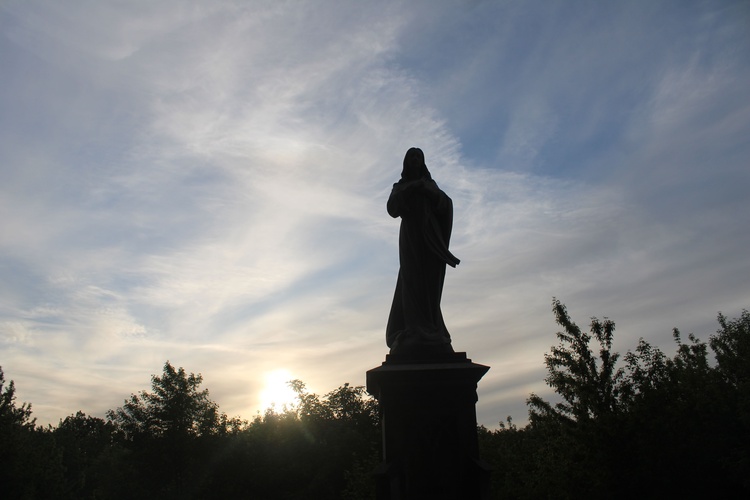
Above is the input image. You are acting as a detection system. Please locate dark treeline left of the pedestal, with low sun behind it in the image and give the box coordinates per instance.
[0,361,380,499]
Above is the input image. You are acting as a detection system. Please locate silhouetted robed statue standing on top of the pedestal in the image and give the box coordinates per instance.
[386,148,459,355]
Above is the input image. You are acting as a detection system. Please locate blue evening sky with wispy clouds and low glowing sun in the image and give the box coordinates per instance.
[0,0,750,428]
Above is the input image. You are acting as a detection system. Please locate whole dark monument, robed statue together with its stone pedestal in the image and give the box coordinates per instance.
[367,148,490,500]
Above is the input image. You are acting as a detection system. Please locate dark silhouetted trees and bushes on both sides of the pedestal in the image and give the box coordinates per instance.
[0,300,750,499]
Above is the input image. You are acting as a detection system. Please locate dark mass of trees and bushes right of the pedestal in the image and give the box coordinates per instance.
[479,300,750,498]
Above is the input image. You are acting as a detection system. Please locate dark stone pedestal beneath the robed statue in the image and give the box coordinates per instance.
[367,353,490,500]
